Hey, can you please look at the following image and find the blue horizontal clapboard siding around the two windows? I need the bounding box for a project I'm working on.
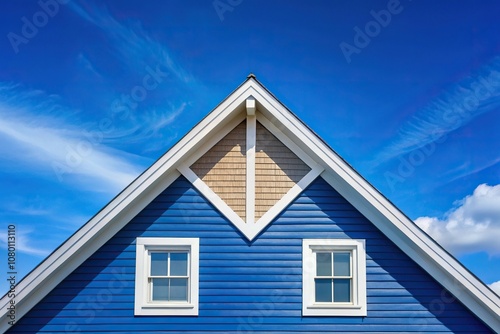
[10,177,490,333]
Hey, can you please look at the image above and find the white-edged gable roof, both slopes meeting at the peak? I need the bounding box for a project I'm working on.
[0,75,500,332]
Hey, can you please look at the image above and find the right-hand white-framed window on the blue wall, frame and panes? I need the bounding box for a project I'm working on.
[302,239,366,316]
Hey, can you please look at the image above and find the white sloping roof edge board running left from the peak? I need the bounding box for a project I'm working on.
[0,80,254,332]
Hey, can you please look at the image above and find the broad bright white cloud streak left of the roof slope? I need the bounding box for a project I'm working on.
[0,84,143,193]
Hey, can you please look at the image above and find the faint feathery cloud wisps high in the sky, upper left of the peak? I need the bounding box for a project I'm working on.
[68,1,201,154]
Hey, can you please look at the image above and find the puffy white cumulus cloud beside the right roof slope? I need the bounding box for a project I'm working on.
[415,184,500,256]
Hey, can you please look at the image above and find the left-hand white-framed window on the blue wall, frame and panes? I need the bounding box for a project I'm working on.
[135,238,199,315]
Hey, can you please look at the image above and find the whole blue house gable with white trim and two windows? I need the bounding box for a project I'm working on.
[0,75,500,333]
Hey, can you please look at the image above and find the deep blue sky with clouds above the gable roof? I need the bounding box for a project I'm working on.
[0,0,500,292]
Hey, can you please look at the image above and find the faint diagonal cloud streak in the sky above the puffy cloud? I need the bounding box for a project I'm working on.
[373,57,500,165]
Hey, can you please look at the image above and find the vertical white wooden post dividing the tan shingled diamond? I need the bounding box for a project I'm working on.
[245,114,257,224]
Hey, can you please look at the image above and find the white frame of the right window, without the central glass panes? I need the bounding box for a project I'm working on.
[302,239,367,316]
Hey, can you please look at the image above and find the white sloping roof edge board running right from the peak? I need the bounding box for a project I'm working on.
[245,79,500,332]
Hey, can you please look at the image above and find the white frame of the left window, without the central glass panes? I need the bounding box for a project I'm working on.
[134,238,200,315]
